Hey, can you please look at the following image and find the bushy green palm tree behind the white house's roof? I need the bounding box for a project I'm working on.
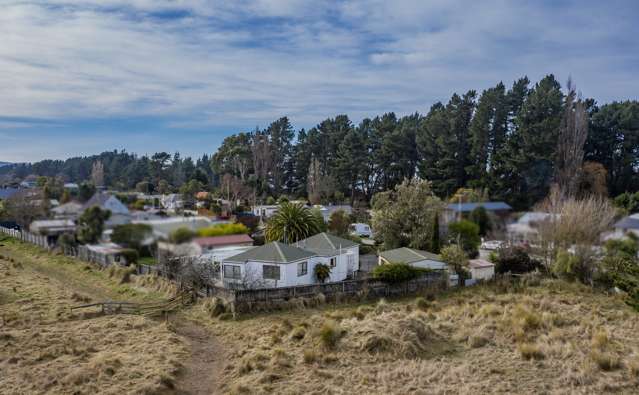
[265,202,320,243]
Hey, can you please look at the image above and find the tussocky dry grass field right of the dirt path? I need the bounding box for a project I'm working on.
[189,280,639,394]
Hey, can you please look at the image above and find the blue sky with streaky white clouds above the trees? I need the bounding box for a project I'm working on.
[0,0,639,162]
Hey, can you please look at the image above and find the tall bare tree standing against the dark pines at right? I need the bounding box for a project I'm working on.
[555,80,588,197]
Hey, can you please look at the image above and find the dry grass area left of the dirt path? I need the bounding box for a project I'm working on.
[0,240,187,394]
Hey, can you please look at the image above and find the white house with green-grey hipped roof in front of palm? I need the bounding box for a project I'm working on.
[221,233,359,288]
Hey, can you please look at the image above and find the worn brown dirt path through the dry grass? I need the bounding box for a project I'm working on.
[172,315,223,395]
